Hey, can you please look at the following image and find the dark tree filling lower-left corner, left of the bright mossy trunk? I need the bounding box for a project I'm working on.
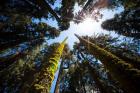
[0,42,42,93]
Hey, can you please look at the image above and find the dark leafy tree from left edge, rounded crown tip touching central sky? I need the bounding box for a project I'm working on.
[0,15,60,50]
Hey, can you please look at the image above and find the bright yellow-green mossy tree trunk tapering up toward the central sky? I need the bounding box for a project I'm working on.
[29,38,67,93]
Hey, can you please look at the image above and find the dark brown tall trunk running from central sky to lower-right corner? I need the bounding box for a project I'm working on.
[76,35,140,93]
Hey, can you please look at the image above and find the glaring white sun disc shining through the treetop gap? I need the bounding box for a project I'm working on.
[78,17,96,34]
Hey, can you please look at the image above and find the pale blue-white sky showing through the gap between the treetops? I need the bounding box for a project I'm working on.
[47,6,123,49]
